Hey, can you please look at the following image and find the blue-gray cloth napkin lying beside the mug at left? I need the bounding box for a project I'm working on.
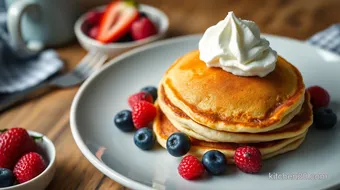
[0,3,64,94]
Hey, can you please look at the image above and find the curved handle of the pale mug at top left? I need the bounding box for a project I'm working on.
[7,0,44,53]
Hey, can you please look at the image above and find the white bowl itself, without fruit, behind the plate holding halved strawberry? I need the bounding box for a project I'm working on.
[74,4,169,57]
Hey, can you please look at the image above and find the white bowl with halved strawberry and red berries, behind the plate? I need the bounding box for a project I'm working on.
[74,0,169,57]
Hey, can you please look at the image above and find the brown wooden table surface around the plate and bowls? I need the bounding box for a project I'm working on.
[0,0,340,190]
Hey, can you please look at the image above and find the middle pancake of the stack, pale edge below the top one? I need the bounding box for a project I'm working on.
[158,86,313,143]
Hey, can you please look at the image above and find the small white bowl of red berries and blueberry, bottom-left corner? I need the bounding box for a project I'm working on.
[0,128,56,190]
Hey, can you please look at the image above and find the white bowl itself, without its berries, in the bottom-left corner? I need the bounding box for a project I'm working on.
[0,131,56,190]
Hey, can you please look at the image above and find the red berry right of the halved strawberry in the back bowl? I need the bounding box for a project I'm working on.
[130,17,157,40]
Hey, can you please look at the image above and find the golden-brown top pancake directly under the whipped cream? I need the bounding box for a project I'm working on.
[161,50,305,133]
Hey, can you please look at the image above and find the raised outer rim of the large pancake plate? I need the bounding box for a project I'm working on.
[70,34,340,190]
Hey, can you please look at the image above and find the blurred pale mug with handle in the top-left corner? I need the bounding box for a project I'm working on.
[6,0,83,52]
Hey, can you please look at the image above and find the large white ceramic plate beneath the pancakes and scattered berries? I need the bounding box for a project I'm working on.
[71,35,340,190]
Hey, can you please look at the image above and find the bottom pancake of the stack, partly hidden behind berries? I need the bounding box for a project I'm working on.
[153,106,307,163]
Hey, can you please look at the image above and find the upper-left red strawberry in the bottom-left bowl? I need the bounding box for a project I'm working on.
[0,128,37,169]
